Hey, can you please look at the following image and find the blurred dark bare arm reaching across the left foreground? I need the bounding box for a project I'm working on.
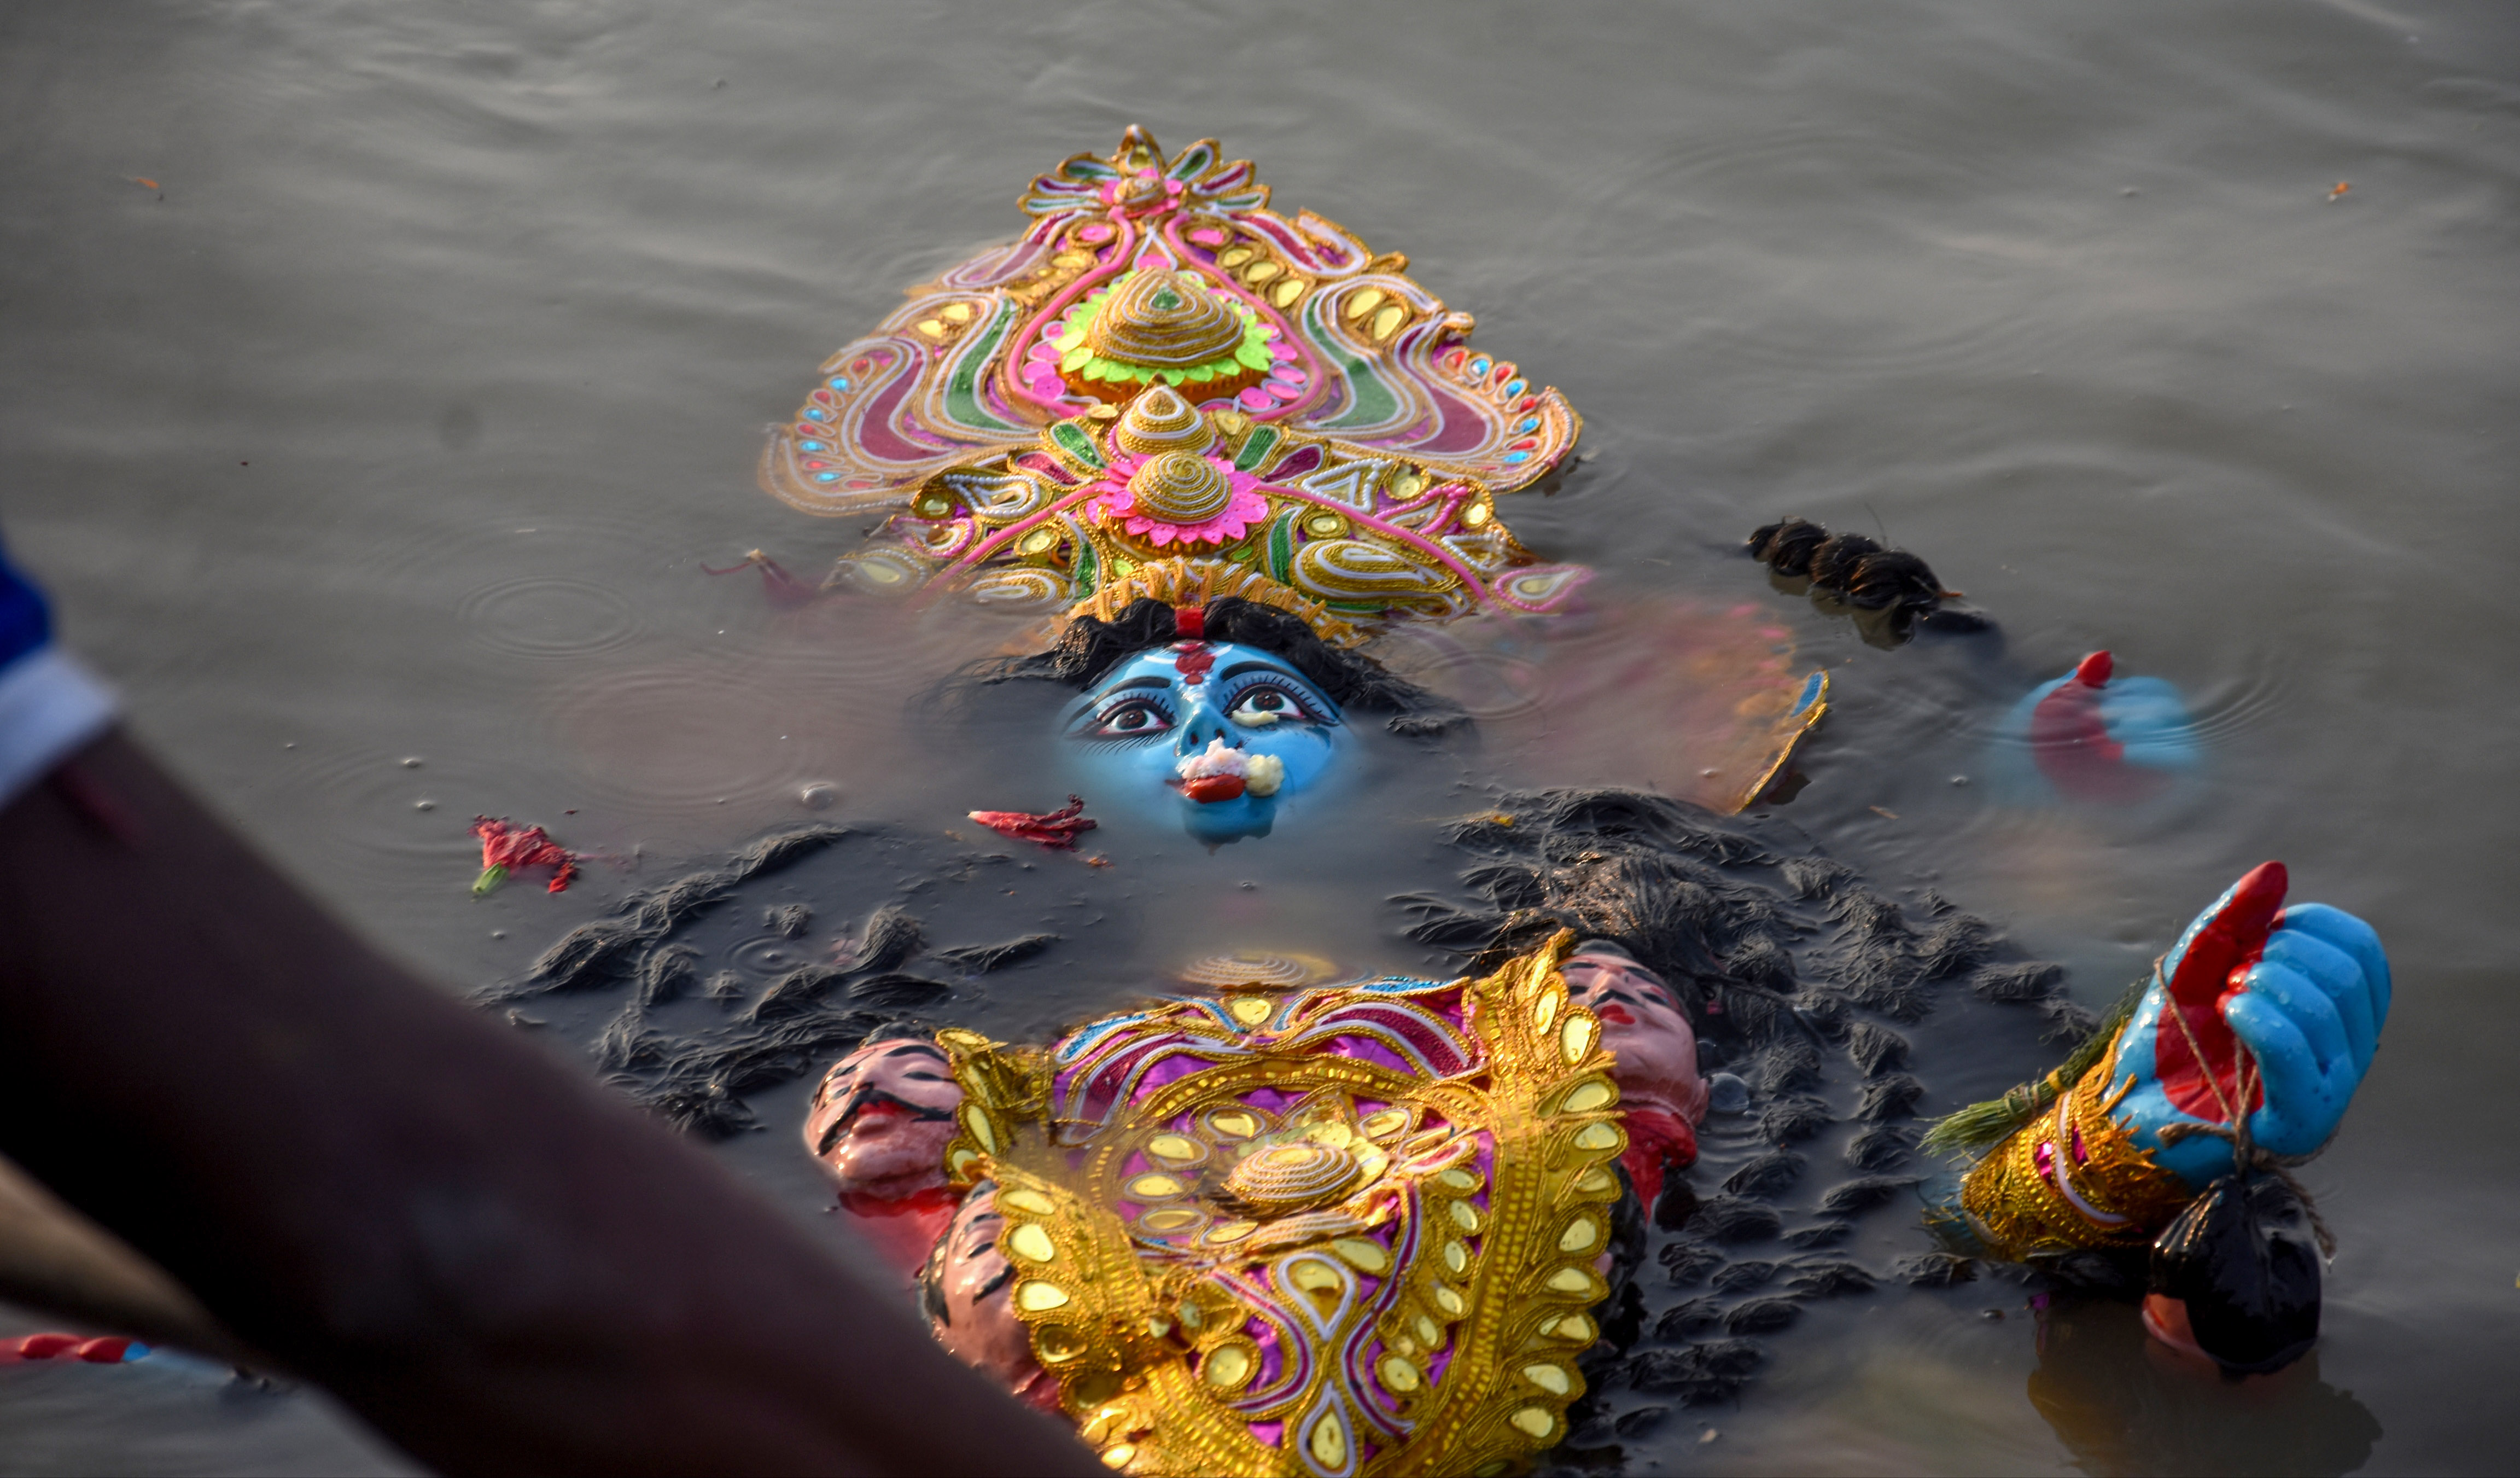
[0,734,1101,1473]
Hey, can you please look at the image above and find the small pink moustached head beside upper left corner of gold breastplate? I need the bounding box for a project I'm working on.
[804,1041,962,1201]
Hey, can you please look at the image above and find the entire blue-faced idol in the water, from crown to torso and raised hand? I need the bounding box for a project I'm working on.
[673,129,2389,1478]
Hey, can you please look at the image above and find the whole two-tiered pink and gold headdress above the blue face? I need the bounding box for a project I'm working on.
[761,126,1588,643]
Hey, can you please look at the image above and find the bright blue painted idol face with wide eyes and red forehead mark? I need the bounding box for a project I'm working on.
[1066,641,1346,845]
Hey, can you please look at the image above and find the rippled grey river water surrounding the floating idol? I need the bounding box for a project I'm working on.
[0,0,2520,1473]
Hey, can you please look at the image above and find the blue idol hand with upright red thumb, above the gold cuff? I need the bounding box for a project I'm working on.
[2112,863,2389,1188]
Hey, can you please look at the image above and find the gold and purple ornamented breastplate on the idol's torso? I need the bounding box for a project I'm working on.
[940,933,1625,1478]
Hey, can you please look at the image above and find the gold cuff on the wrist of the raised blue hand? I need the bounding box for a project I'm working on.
[1961,1027,2195,1261]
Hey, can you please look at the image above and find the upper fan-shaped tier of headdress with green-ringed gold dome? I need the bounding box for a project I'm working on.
[761,126,1583,515]
